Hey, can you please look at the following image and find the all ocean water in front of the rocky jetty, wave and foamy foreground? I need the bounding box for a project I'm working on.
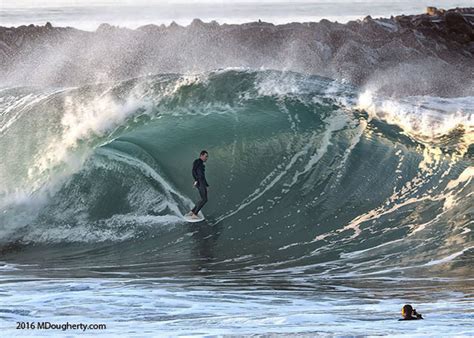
[0,69,474,337]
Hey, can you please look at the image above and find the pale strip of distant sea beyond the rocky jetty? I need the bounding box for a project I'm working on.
[0,0,472,31]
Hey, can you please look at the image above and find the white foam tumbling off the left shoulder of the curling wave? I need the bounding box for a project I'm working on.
[0,74,207,211]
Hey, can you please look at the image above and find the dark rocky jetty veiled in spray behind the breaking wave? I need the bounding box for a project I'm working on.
[0,7,474,96]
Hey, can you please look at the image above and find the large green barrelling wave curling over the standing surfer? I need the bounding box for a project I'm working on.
[0,70,473,274]
